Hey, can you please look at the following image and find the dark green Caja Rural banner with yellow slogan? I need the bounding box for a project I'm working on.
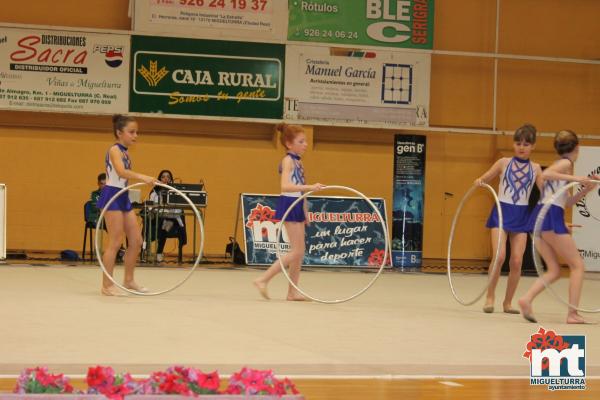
[130,36,285,119]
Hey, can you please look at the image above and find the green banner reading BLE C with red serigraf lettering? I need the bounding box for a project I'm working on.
[288,0,434,49]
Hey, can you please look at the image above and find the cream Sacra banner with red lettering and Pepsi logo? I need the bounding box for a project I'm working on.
[0,27,129,114]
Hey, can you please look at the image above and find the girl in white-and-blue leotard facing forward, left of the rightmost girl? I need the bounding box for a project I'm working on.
[475,124,542,314]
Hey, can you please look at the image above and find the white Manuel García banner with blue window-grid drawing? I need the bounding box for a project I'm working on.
[285,45,431,126]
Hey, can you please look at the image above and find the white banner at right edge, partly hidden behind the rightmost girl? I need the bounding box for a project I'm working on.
[573,146,600,271]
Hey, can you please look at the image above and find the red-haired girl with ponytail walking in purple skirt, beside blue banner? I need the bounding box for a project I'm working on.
[254,123,325,301]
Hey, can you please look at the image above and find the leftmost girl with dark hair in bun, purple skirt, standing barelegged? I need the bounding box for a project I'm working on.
[97,114,155,296]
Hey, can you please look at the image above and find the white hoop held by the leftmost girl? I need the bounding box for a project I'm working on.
[95,182,204,296]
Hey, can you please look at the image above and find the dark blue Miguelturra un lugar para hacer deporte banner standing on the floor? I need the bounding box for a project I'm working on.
[241,193,389,268]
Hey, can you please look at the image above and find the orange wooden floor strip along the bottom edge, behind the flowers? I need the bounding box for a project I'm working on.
[0,378,600,400]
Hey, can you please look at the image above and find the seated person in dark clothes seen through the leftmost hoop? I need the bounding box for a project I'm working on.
[150,169,187,262]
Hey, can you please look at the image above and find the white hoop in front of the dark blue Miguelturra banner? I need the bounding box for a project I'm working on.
[275,186,390,304]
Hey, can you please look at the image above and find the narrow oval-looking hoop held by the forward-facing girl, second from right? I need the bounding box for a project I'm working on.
[446,183,504,306]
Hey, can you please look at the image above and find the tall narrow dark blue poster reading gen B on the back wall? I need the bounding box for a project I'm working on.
[392,135,426,270]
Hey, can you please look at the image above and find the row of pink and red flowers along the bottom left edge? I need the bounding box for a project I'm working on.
[14,365,299,400]
